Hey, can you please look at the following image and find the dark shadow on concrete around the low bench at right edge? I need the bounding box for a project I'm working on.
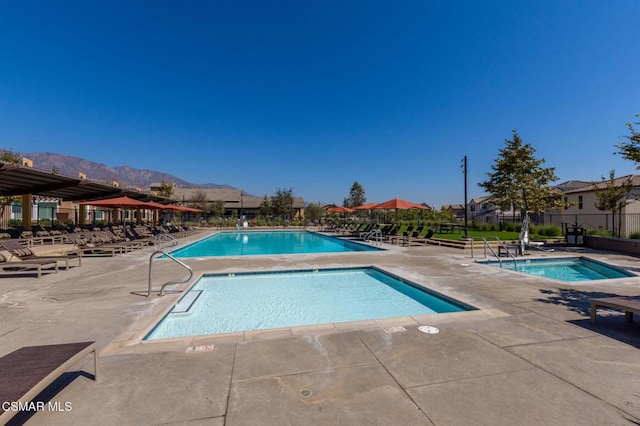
[536,288,640,349]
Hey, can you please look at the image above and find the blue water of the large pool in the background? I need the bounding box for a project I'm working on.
[171,231,380,257]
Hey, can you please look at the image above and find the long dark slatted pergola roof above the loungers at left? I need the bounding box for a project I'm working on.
[0,162,172,229]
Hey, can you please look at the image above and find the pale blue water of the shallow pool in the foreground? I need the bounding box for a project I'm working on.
[145,268,474,340]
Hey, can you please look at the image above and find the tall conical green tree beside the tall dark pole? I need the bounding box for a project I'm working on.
[478,130,562,219]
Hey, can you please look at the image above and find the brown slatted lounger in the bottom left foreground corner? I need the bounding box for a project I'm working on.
[0,342,98,424]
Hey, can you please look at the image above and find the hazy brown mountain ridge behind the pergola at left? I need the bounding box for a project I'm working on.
[24,152,238,190]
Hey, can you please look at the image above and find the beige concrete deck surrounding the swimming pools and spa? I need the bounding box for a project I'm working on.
[0,233,640,426]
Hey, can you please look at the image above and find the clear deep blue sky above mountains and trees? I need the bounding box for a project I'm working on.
[0,0,640,207]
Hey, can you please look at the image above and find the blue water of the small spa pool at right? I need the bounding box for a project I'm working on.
[487,257,636,281]
